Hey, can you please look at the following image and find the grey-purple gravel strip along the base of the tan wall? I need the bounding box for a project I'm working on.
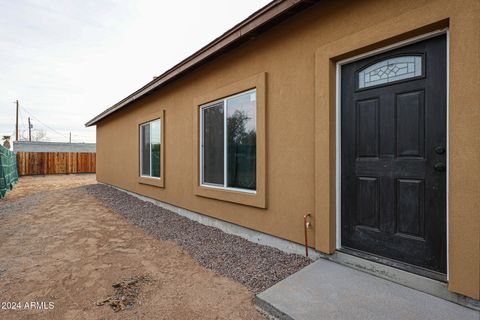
[82,184,312,293]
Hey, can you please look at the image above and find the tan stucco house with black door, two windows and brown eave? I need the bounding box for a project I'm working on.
[86,0,480,303]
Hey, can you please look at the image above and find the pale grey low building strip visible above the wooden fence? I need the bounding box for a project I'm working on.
[13,141,96,153]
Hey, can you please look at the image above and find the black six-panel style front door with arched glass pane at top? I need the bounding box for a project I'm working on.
[341,36,447,274]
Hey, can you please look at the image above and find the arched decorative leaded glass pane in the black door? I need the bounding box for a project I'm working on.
[358,55,423,89]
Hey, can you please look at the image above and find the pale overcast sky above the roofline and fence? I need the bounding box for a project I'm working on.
[0,0,270,142]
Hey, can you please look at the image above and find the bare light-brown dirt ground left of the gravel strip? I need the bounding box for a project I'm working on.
[0,175,263,319]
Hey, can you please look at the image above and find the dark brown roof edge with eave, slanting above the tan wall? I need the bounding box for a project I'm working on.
[85,0,318,127]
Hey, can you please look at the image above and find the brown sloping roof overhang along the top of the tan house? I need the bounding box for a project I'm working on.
[85,0,320,127]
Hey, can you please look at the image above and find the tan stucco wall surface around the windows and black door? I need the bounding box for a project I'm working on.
[97,0,480,299]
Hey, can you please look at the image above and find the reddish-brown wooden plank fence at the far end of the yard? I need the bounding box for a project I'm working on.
[17,152,96,176]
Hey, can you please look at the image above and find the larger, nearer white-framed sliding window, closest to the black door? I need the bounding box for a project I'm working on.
[200,89,257,193]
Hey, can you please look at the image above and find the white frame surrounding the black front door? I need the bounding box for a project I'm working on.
[335,28,450,281]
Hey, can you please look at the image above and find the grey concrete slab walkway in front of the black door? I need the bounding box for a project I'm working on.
[256,259,480,320]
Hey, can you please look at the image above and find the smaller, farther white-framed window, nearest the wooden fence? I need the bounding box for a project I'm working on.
[140,119,161,179]
